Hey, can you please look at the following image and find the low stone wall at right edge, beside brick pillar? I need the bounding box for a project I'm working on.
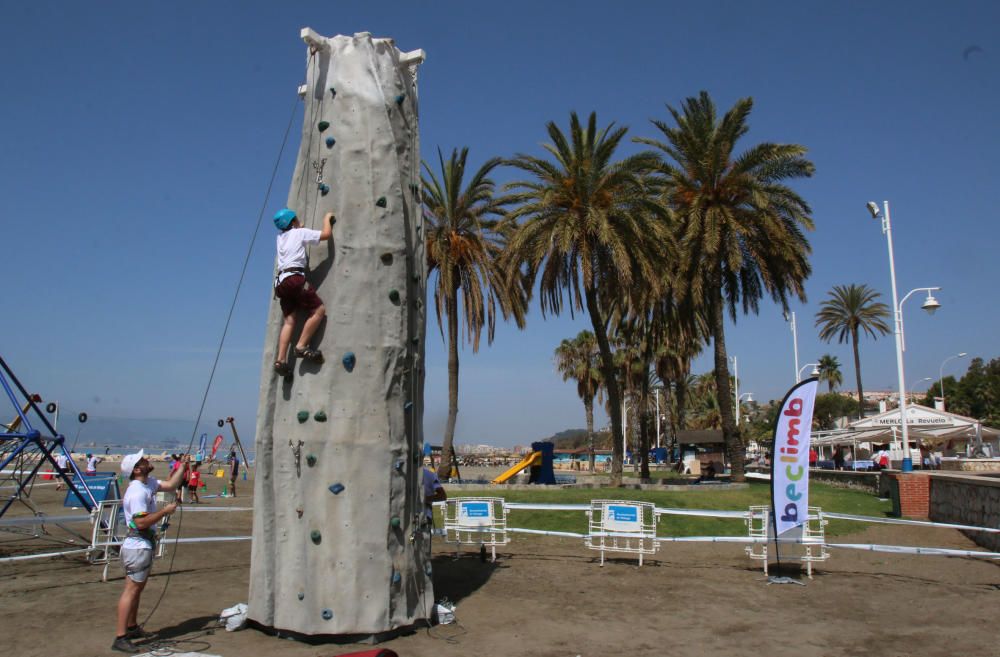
[930,472,1000,552]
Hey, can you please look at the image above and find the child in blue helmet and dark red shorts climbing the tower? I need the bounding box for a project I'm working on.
[274,208,336,377]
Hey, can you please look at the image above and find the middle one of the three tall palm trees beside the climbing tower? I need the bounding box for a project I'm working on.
[506,112,672,483]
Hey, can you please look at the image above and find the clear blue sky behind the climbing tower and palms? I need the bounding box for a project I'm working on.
[0,0,1000,446]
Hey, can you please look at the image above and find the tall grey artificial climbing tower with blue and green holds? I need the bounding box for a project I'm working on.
[249,31,434,635]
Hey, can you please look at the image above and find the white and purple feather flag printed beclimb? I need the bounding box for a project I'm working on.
[771,378,819,537]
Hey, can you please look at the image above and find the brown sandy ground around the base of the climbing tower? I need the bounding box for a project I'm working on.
[0,478,1000,657]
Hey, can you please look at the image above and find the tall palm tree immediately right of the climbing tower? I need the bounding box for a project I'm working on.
[422,148,527,477]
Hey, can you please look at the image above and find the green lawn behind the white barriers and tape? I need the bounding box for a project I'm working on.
[446,482,892,536]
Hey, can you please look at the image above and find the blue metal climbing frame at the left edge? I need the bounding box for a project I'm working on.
[0,356,97,518]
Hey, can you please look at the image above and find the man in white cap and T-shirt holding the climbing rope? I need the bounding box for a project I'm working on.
[111,450,187,653]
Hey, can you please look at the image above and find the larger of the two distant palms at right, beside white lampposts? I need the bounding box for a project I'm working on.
[816,283,891,418]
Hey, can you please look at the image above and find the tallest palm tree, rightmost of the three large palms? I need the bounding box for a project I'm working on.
[639,91,814,481]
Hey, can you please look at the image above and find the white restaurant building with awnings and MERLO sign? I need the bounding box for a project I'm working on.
[812,404,1000,462]
